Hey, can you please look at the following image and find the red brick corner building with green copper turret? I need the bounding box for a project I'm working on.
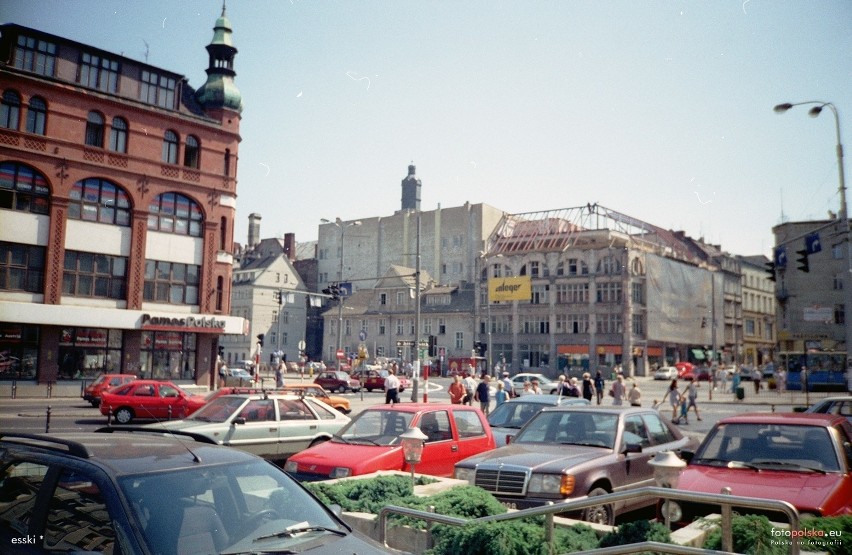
[0,10,245,385]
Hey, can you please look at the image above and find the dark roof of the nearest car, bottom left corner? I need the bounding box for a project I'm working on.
[0,430,255,475]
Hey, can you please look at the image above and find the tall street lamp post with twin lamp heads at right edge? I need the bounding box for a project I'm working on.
[774,100,852,394]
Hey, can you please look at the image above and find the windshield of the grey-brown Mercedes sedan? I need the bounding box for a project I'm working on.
[512,411,618,449]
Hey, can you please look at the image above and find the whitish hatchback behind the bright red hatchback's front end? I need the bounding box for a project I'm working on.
[145,394,349,460]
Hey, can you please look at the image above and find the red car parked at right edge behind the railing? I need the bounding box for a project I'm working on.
[663,413,852,523]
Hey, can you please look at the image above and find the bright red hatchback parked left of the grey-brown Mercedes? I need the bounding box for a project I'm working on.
[284,403,494,480]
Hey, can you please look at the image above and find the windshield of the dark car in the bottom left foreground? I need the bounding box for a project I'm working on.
[119,461,349,555]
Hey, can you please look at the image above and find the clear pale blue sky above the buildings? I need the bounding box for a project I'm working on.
[0,0,852,255]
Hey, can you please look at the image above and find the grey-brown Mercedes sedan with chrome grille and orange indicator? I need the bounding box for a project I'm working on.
[455,406,698,524]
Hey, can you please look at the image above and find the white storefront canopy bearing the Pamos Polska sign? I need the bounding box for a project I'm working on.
[0,301,248,335]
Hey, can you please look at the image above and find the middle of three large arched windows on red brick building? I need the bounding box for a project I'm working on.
[68,177,130,226]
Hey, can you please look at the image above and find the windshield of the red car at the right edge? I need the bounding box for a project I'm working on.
[692,423,840,472]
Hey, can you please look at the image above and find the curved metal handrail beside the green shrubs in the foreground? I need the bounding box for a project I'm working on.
[379,486,799,555]
